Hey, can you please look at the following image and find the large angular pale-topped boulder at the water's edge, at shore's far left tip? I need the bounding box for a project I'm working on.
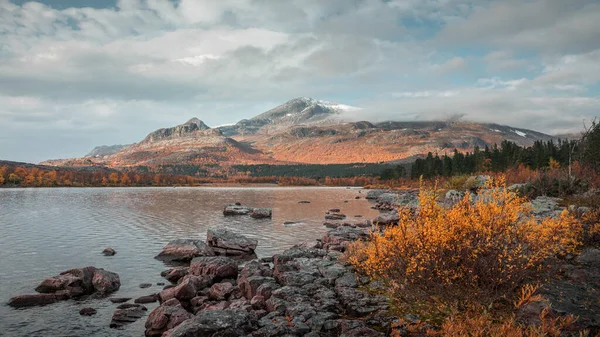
[206,227,258,256]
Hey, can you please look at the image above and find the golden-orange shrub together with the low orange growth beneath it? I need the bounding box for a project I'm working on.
[345,178,597,336]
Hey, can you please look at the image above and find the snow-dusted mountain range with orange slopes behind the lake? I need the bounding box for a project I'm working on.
[45,97,553,171]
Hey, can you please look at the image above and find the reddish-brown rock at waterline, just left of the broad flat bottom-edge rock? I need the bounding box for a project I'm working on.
[145,299,193,337]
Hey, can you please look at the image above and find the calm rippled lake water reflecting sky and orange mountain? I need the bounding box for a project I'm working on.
[0,187,377,337]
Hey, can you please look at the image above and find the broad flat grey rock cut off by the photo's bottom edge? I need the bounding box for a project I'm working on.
[163,310,250,337]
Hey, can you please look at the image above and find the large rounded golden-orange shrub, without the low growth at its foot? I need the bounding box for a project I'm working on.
[345,178,581,308]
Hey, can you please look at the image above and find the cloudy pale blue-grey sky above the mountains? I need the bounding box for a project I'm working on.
[0,0,600,162]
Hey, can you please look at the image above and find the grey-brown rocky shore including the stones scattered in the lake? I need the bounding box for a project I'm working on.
[9,191,600,337]
